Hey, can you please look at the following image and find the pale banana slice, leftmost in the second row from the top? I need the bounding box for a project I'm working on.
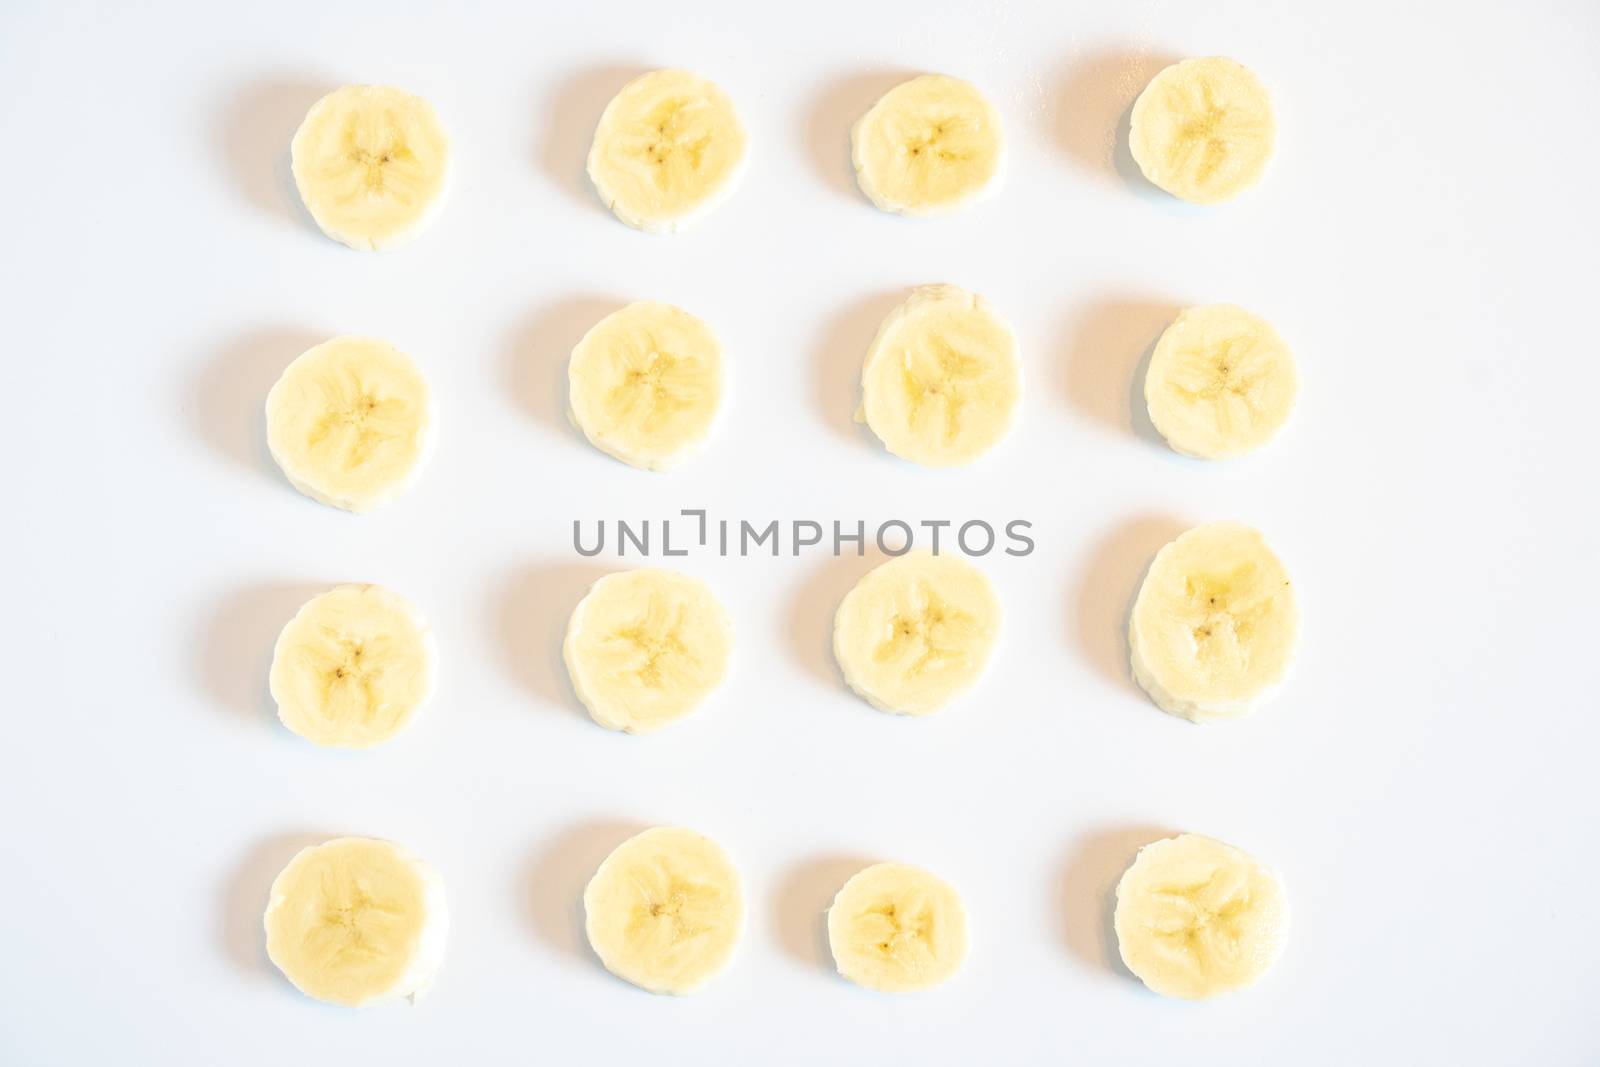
[267,338,434,512]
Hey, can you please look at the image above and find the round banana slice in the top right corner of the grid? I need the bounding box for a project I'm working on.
[1128,58,1277,203]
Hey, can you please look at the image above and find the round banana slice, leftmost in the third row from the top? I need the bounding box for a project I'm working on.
[269,585,437,749]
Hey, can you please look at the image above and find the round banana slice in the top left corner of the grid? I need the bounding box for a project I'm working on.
[290,85,450,251]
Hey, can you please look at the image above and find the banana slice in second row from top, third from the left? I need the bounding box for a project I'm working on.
[861,285,1022,467]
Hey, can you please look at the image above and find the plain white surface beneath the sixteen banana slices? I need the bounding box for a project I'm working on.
[0,0,1600,1064]
